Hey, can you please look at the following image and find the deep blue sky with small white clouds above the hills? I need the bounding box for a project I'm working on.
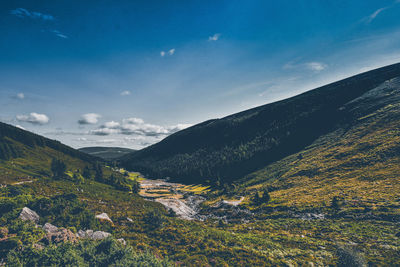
[0,0,400,149]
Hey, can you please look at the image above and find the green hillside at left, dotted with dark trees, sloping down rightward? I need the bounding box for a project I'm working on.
[0,122,101,183]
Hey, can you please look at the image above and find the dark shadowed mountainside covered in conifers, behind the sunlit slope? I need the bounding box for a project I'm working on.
[121,64,400,183]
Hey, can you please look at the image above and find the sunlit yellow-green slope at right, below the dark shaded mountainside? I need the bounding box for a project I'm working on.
[236,77,400,208]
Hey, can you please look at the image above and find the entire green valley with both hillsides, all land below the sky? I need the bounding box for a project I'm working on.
[0,64,400,266]
